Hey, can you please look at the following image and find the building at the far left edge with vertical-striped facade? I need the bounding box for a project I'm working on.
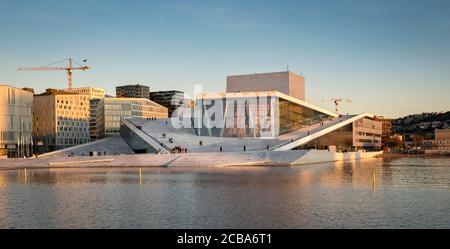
[0,85,33,157]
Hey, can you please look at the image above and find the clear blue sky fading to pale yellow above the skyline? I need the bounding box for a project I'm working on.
[0,0,450,117]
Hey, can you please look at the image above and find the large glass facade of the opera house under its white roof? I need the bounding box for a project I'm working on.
[194,95,330,138]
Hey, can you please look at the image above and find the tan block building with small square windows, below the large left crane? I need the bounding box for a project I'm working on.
[33,89,90,153]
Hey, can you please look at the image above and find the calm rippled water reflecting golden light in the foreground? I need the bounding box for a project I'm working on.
[0,158,450,228]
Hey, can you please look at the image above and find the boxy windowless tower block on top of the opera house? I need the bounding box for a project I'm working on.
[227,71,305,100]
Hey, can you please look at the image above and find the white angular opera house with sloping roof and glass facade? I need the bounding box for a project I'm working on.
[42,72,382,162]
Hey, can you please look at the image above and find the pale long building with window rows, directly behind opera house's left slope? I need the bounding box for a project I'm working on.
[97,98,168,137]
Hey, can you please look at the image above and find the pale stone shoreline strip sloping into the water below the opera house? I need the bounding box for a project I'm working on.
[0,150,382,170]
